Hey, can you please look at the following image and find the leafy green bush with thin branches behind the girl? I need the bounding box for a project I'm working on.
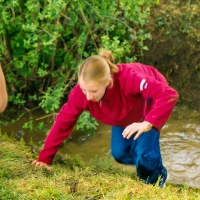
[0,0,158,133]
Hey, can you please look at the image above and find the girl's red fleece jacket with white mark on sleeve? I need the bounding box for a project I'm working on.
[38,63,178,164]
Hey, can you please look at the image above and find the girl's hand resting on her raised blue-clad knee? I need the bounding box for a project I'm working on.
[122,121,153,140]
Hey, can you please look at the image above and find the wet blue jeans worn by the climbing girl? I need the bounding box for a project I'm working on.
[111,126,164,184]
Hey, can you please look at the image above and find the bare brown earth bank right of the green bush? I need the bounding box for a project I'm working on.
[144,0,200,110]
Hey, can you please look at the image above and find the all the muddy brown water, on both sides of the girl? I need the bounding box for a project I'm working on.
[1,106,200,188]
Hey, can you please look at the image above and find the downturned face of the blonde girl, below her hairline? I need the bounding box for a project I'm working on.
[79,79,111,102]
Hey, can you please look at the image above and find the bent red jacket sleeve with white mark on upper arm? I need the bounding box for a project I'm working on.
[132,74,178,130]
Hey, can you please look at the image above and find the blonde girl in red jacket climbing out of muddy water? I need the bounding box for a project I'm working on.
[32,50,178,187]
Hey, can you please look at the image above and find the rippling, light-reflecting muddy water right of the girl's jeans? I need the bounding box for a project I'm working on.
[161,108,200,188]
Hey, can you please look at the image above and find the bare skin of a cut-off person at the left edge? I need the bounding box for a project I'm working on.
[0,64,8,113]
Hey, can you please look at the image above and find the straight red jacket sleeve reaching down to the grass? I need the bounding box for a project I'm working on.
[38,86,87,164]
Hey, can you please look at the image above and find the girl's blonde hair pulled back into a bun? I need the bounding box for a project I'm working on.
[78,50,118,82]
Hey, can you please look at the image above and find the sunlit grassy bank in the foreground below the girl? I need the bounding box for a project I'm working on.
[0,134,200,200]
